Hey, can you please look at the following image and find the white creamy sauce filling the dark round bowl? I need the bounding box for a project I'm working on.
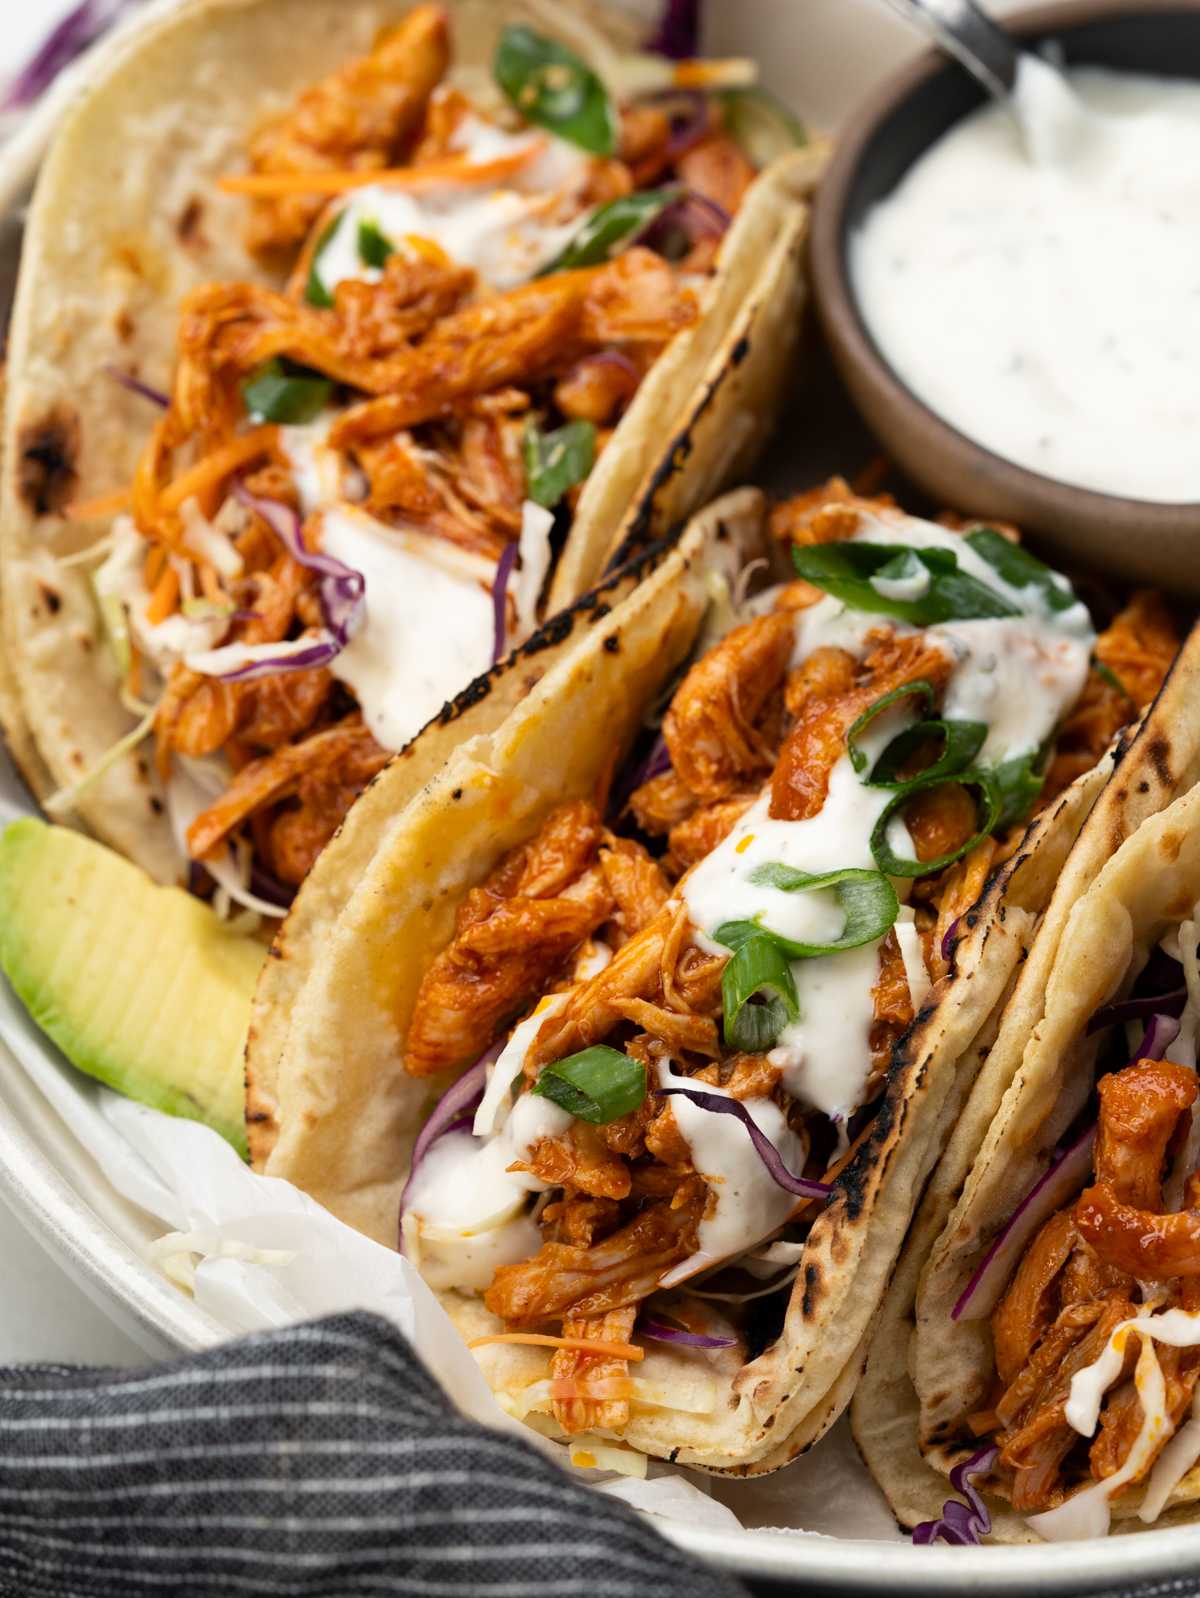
[850,56,1200,503]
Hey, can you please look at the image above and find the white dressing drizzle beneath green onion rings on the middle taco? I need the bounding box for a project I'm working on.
[682,513,1095,1123]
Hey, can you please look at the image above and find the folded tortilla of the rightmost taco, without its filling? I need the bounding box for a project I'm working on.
[852,631,1200,1542]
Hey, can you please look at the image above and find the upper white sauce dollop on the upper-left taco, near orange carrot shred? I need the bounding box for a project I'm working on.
[313,118,588,294]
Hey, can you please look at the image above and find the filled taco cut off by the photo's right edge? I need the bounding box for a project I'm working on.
[853,631,1200,1542]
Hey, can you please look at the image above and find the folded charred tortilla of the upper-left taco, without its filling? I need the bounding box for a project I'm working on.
[0,0,828,882]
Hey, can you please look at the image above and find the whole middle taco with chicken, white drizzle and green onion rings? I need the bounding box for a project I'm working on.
[248,483,1170,1475]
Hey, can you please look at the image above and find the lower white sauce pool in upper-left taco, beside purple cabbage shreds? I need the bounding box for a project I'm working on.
[321,505,495,749]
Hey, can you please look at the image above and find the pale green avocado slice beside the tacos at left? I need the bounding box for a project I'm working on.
[0,817,267,1155]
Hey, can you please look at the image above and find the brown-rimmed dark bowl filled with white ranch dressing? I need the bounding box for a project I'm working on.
[812,0,1200,594]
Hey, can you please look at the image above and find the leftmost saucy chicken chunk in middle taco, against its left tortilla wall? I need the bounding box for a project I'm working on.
[404,801,620,1077]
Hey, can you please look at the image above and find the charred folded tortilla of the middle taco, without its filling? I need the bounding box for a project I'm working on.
[248,491,1137,1475]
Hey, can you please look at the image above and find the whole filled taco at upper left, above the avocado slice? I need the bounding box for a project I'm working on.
[0,0,823,916]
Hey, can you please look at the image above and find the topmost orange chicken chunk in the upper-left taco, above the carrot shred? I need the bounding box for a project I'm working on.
[248,5,451,256]
